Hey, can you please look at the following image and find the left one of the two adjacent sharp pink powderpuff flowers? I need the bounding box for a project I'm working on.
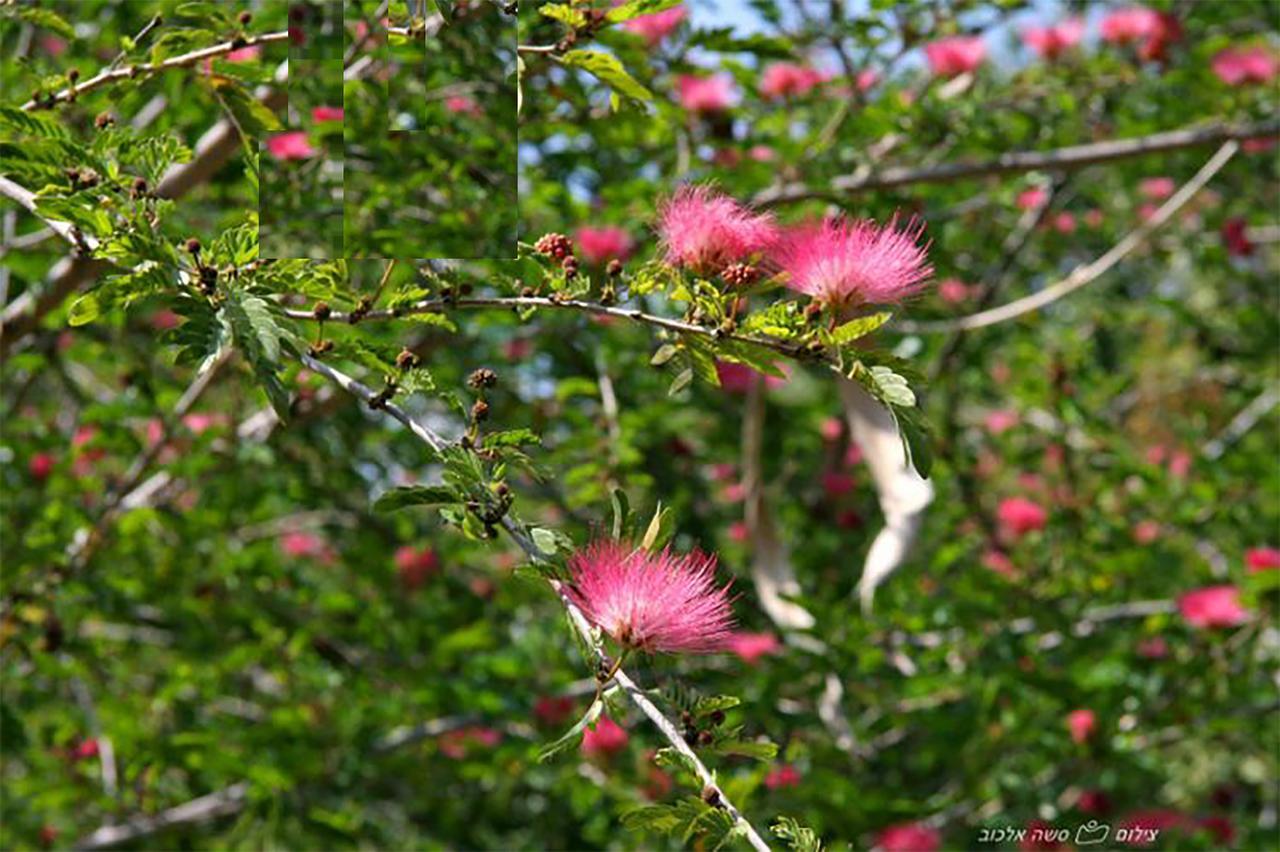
[658,185,778,275]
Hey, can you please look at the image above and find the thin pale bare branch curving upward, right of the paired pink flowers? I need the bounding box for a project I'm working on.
[897,139,1240,334]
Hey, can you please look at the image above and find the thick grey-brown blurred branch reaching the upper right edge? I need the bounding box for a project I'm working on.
[753,119,1280,206]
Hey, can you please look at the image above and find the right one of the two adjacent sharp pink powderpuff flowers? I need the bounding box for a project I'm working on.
[777,216,933,307]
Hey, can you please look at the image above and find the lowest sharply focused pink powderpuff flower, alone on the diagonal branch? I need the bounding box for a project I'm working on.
[567,540,733,654]
